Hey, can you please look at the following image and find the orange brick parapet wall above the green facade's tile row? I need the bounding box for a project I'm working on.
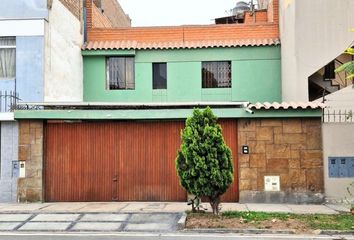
[88,23,279,42]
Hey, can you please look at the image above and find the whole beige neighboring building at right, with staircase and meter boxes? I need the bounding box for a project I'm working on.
[279,0,354,201]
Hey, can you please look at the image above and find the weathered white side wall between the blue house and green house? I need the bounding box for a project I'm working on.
[44,1,83,102]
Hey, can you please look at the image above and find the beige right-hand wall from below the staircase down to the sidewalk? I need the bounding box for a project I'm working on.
[322,86,354,202]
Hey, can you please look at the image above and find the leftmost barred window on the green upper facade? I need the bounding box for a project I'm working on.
[106,57,135,90]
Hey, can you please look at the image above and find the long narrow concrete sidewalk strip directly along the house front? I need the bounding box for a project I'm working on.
[0,202,349,214]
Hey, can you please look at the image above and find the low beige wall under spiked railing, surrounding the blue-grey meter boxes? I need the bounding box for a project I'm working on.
[323,123,354,202]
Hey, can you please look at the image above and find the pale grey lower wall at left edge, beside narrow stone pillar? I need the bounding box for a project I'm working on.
[0,122,18,202]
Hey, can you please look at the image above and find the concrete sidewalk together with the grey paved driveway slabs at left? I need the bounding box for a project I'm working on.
[0,202,348,232]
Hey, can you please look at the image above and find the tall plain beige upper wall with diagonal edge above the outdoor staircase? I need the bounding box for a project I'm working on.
[280,0,354,101]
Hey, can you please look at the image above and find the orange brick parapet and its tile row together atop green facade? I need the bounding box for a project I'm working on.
[82,24,280,50]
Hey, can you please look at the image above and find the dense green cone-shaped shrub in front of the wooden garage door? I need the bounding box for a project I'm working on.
[176,107,234,214]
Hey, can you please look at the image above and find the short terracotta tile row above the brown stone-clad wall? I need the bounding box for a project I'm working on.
[247,102,325,110]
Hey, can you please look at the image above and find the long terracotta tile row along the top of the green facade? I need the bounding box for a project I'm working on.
[82,39,280,50]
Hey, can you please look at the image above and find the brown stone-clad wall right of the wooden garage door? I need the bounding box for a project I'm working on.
[238,118,324,203]
